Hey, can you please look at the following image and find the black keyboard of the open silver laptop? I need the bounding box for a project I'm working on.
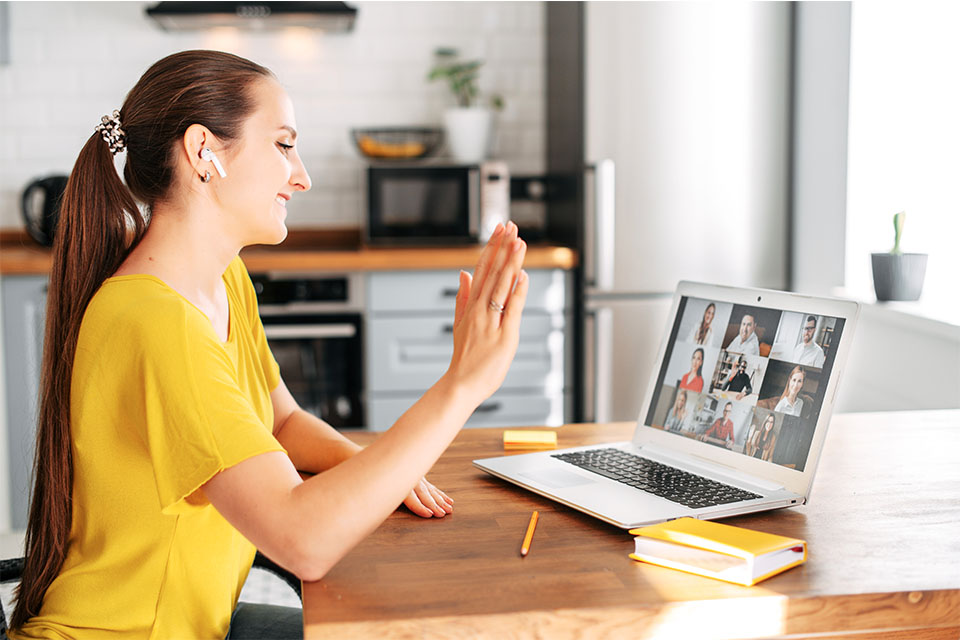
[553,449,762,509]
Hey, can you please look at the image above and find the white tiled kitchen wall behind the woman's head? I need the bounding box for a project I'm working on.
[0,2,545,227]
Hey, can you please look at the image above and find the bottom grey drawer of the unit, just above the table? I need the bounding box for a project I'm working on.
[367,390,569,431]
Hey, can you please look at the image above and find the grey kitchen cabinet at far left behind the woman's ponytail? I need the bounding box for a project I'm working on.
[0,275,48,530]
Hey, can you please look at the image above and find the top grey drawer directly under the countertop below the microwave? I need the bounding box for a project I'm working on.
[367,269,569,317]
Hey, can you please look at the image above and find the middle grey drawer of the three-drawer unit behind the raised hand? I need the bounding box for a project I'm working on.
[366,313,566,394]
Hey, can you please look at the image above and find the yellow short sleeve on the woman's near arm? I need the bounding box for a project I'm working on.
[139,305,284,515]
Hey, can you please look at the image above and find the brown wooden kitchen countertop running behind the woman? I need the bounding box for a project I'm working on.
[0,229,579,275]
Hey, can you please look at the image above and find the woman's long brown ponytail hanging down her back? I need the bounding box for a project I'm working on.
[10,133,146,628]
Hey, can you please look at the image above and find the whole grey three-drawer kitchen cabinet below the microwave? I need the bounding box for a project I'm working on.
[364,269,572,431]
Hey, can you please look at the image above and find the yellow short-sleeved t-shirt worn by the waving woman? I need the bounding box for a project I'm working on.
[14,257,283,639]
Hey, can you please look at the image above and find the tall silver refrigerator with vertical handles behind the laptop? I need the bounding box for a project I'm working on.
[547,2,793,422]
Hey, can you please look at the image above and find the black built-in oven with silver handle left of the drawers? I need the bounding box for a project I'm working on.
[251,273,365,429]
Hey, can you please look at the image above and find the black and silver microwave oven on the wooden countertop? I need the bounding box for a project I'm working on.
[365,162,510,245]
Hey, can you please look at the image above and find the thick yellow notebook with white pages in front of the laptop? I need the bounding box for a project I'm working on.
[630,518,807,587]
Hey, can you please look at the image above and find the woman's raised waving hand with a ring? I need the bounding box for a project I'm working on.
[447,222,530,405]
